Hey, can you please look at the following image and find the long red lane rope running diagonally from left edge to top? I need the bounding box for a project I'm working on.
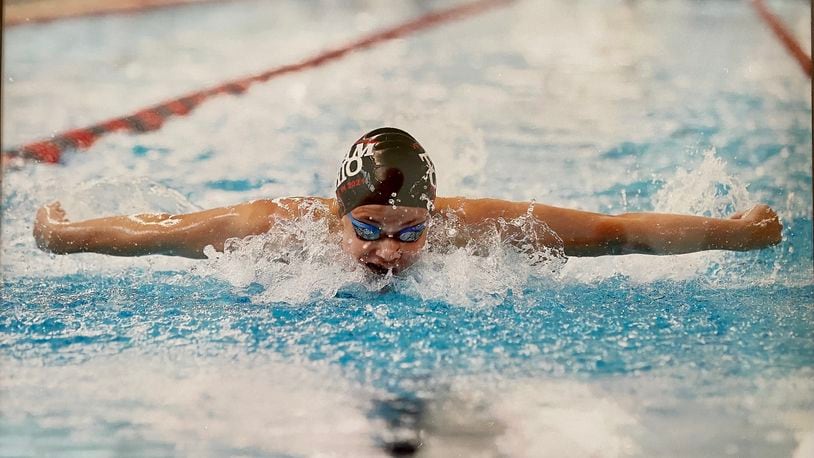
[2,0,513,165]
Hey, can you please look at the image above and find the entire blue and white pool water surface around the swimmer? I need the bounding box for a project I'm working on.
[0,0,814,457]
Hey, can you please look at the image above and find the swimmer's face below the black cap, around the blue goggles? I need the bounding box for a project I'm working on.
[342,205,430,273]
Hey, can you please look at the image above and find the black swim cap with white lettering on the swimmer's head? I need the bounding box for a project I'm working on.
[336,127,435,216]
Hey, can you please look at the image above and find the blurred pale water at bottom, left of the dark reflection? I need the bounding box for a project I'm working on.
[0,352,381,456]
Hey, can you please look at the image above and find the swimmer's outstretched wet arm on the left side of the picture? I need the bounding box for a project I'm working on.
[34,199,330,259]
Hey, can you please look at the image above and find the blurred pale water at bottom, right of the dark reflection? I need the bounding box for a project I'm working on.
[419,369,814,458]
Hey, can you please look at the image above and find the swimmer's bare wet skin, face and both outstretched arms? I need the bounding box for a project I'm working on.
[32,197,783,272]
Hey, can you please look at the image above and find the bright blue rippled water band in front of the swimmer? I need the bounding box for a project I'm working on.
[0,272,814,380]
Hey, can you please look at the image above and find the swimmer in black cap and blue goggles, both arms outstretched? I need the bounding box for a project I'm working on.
[34,127,782,273]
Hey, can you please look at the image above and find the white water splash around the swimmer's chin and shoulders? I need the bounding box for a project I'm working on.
[197,204,565,307]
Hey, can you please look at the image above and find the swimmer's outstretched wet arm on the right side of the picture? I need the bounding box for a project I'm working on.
[439,198,782,256]
